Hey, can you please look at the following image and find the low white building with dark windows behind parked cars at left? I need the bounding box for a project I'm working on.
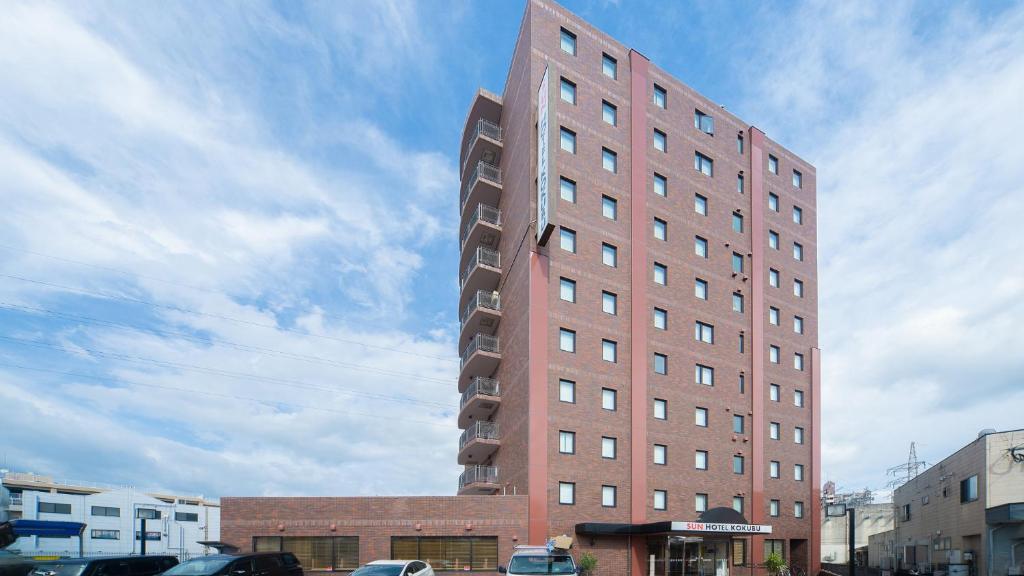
[0,472,220,557]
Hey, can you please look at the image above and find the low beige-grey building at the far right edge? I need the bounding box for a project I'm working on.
[888,429,1024,576]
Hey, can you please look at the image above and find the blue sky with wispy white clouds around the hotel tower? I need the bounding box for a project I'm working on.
[0,0,1024,495]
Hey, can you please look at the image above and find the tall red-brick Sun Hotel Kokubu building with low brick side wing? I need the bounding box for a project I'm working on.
[223,0,820,576]
